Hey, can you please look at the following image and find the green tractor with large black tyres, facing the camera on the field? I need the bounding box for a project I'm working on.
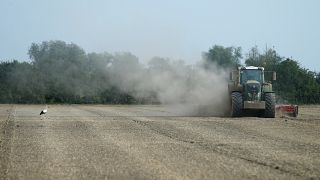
[228,66,276,118]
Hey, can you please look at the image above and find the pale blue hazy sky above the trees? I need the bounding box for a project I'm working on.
[0,0,320,71]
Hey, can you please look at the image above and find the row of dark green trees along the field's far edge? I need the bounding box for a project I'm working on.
[0,41,320,104]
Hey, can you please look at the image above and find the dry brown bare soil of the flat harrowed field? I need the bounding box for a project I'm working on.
[0,105,320,179]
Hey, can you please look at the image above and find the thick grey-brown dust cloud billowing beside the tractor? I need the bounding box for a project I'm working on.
[109,56,229,116]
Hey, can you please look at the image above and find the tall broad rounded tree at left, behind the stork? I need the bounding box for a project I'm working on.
[29,41,89,102]
